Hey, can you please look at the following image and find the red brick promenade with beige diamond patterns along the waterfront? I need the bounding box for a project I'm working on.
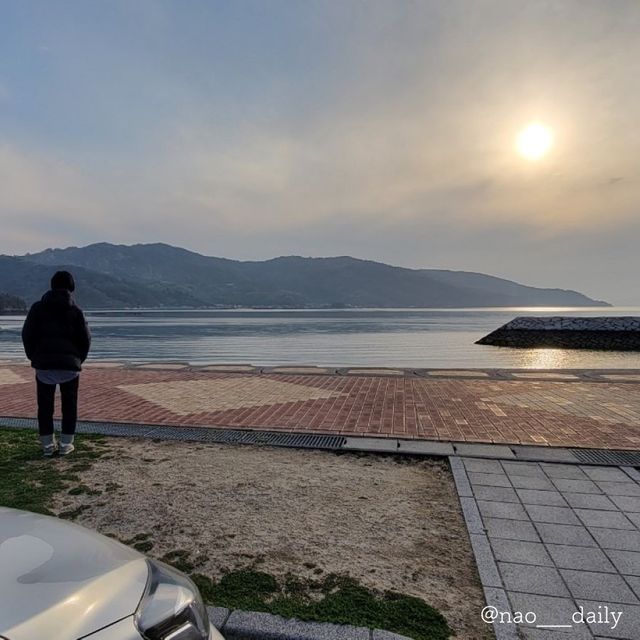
[0,363,640,450]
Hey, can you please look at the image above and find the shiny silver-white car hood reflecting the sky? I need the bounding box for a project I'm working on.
[0,507,148,640]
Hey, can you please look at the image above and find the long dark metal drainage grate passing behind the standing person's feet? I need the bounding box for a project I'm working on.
[0,417,347,450]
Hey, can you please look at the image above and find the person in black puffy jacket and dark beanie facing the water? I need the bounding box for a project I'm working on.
[22,271,91,457]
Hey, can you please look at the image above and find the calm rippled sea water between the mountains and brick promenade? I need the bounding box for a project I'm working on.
[0,308,640,369]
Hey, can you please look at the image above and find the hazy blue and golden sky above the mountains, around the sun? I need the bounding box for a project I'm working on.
[0,0,640,305]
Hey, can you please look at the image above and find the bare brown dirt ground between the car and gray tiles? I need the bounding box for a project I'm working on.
[55,438,493,640]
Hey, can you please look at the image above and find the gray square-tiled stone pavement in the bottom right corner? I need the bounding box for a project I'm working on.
[450,457,640,640]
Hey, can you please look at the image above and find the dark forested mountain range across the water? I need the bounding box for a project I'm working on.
[0,242,609,309]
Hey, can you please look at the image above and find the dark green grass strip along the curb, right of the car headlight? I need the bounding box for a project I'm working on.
[191,569,453,640]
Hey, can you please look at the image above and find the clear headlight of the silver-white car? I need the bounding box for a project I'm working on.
[135,560,210,640]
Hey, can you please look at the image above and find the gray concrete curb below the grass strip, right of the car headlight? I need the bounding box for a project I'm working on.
[207,607,411,640]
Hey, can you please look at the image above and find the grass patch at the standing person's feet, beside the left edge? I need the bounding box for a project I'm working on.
[0,427,105,518]
